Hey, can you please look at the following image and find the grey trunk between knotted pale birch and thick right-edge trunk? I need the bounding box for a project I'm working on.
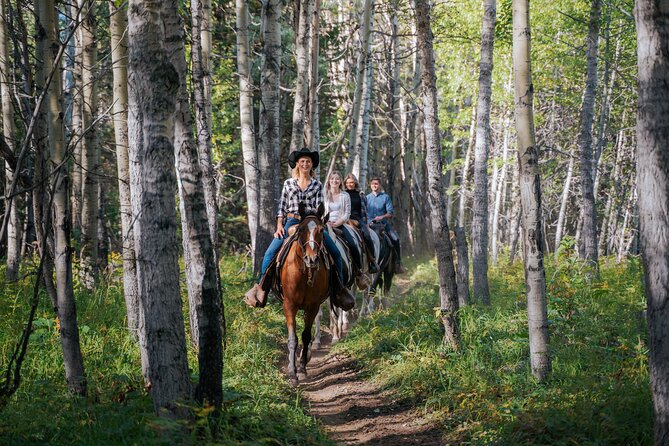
[578,0,601,269]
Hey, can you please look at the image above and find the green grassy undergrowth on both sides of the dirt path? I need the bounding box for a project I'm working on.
[0,255,652,445]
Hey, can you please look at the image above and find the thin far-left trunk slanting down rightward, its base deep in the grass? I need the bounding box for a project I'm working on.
[35,0,86,395]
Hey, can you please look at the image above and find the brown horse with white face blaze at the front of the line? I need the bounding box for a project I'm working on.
[275,204,336,385]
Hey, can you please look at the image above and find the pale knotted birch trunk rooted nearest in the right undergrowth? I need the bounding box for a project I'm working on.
[513,0,551,382]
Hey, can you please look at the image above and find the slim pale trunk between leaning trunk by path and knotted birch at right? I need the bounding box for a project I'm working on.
[472,0,497,305]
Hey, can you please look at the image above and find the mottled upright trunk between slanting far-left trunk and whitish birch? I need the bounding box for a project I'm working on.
[79,0,100,290]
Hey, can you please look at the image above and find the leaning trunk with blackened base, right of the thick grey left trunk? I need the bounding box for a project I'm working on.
[162,2,223,408]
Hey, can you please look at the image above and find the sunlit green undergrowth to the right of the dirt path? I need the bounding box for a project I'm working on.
[337,257,653,445]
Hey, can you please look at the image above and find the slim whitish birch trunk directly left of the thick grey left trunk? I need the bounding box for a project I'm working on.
[109,1,139,337]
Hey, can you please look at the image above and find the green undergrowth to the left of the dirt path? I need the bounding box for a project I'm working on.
[0,254,331,445]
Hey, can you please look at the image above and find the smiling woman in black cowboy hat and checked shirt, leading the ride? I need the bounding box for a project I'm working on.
[244,147,355,307]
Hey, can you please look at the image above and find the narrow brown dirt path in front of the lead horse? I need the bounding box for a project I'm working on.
[300,339,442,446]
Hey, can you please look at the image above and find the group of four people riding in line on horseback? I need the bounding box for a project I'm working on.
[244,148,405,309]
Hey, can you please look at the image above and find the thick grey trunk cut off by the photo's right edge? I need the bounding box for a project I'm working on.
[635,0,669,446]
